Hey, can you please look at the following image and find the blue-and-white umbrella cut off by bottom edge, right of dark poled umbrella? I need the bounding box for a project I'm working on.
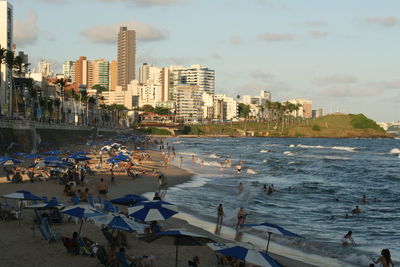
[207,243,281,267]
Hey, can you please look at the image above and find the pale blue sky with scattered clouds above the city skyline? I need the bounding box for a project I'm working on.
[9,0,400,121]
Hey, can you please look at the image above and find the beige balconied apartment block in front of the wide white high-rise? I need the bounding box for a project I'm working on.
[174,84,203,122]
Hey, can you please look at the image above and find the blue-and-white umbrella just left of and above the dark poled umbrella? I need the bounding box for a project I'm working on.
[93,213,144,234]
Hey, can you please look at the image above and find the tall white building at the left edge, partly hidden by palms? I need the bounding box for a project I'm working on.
[0,1,13,114]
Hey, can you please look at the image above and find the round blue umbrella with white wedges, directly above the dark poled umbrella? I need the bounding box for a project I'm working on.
[128,200,178,222]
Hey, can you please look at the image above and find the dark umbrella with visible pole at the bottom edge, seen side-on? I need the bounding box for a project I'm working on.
[143,229,214,267]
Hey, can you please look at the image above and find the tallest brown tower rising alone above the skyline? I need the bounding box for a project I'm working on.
[118,27,136,91]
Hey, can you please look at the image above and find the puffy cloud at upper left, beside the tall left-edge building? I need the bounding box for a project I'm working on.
[14,10,39,47]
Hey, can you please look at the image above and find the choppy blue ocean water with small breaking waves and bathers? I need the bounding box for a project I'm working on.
[165,138,400,266]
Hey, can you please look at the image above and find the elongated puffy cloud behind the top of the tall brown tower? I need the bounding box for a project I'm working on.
[80,20,169,44]
